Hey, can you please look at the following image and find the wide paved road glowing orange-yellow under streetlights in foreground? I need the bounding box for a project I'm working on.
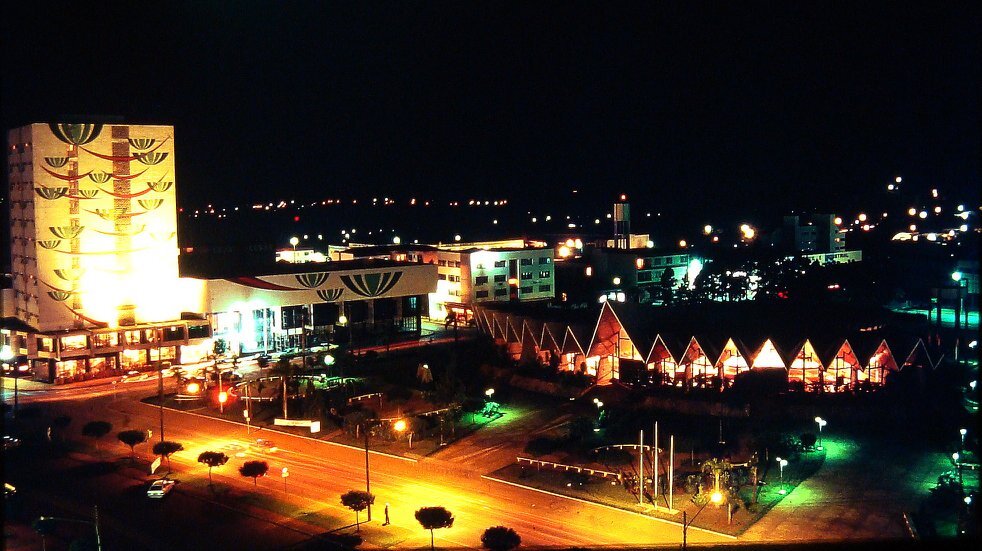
[26,398,728,548]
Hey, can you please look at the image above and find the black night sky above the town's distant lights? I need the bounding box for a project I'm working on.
[2,1,982,216]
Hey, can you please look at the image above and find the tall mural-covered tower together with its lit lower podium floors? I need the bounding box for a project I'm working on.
[4,123,210,380]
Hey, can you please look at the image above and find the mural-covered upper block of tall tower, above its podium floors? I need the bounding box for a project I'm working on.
[8,124,180,332]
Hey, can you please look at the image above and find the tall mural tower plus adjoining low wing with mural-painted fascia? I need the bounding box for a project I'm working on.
[2,124,437,383]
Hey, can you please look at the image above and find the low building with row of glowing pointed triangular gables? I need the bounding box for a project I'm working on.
[475,301,940,393]
